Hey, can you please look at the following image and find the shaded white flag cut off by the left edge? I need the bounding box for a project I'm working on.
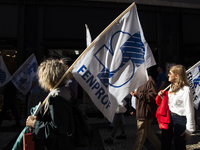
[0,56,11,87]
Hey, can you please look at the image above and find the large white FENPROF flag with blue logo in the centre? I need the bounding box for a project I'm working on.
[72,3,156,122]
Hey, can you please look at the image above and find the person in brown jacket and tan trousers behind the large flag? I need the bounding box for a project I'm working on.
[130,68,161,150]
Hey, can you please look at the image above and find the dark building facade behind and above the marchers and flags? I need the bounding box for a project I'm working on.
[0,0,200,115]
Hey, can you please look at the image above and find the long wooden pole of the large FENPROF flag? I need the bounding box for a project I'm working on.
[34,3,135,115]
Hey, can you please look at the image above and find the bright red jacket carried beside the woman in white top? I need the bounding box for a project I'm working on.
[155,91,170,129]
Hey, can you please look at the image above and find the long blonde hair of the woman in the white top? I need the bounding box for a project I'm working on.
[169,65,189,93]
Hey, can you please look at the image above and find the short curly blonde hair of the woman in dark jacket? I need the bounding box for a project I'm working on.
[37,59,69,91]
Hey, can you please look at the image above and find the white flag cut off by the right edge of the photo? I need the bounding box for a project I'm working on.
[187,62,200,109]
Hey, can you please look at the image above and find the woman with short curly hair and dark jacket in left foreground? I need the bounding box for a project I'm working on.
[26,59,74,150]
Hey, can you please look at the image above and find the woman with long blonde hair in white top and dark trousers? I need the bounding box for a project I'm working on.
[158,65,195,150]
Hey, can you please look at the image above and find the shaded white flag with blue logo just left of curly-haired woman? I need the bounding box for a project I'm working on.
[12,54,38,95]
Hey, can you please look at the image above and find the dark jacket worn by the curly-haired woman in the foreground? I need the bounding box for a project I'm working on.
[32,87,74,150]
